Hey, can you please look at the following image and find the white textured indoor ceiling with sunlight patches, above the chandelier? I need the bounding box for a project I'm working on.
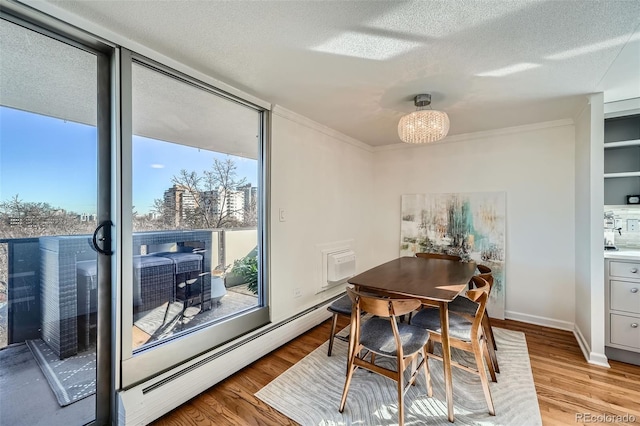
[26,0,640,146]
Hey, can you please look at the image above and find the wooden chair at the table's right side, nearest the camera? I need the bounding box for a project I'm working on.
[411,275,495,416]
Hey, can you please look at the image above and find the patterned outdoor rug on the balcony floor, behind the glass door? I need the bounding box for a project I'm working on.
[27,339,96,407]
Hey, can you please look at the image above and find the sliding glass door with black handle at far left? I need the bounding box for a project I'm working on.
[0,15,111,425]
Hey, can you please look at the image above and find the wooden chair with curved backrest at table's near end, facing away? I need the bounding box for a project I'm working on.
[340,288,433,425]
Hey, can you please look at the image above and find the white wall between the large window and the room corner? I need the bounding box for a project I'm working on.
[270,107,374,322]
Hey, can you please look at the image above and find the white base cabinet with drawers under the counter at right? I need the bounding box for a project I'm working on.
[605,259,640,365]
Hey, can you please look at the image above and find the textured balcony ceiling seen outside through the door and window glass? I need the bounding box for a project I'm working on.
[0,20,260,158]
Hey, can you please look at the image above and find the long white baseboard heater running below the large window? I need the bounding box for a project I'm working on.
[117,296,339,426]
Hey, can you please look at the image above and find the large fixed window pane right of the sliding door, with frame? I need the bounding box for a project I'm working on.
[123,57,268,384]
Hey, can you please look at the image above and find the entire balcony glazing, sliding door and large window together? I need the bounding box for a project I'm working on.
[0,3,269,425]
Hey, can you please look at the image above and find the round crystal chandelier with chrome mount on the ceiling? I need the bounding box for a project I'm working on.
[398,94,449,143]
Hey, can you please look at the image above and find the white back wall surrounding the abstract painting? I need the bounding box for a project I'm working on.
[373,121,575,330]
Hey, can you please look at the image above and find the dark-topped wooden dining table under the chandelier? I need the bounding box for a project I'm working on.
[348,257,476,422]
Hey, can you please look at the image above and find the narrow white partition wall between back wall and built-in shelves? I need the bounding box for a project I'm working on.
[575,93,608,365]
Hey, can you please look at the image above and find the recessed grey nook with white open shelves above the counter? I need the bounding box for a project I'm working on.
[604,114,640,205]
